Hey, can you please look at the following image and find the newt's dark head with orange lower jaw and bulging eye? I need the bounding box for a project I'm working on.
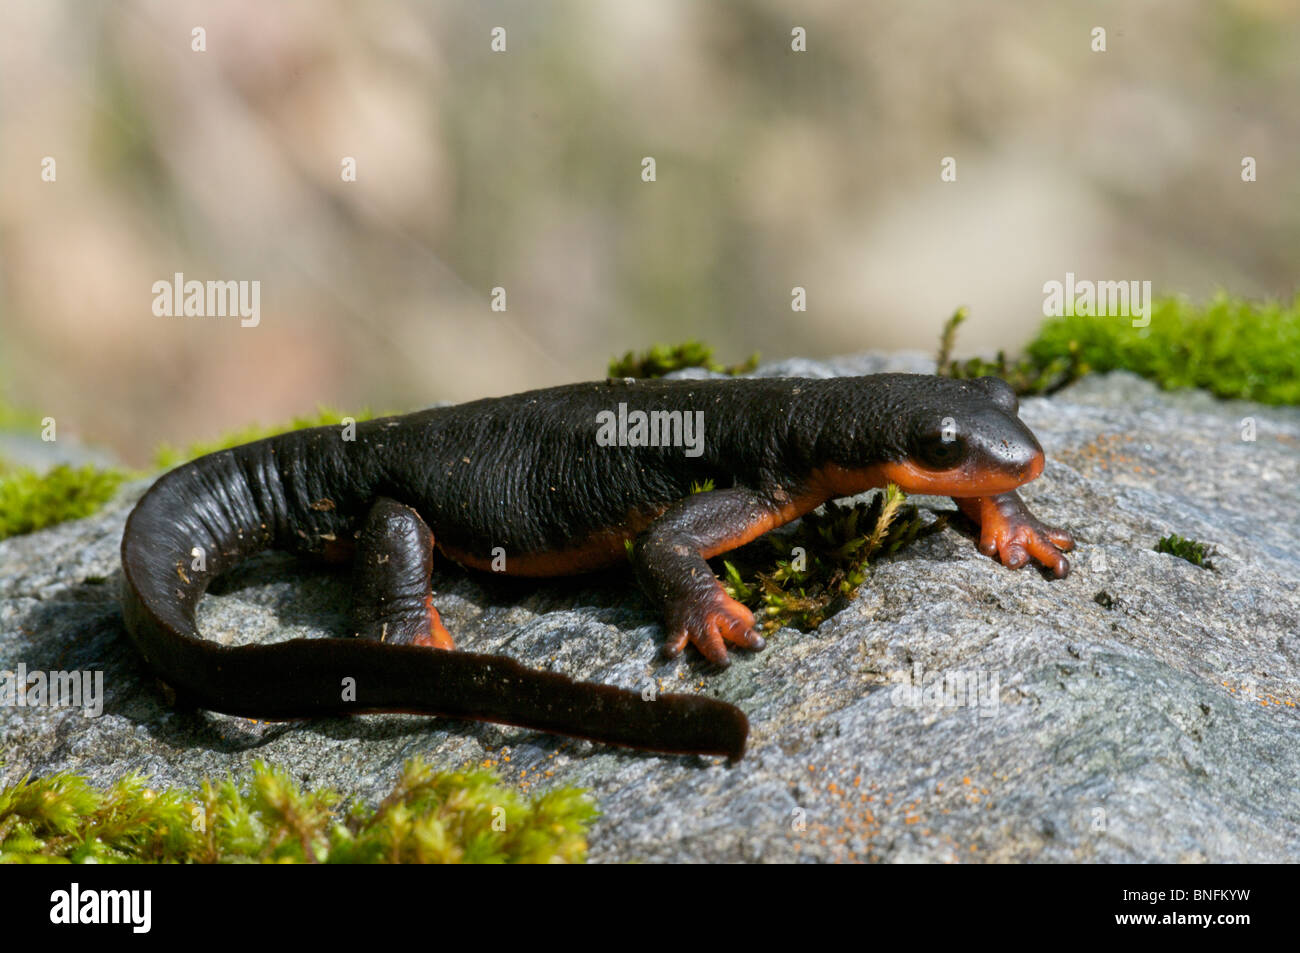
[835,374,1044,497]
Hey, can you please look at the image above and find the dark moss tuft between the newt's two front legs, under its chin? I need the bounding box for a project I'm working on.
[723,484,946,631]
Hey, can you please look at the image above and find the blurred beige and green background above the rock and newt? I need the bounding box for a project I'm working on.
[0,0,1300,464]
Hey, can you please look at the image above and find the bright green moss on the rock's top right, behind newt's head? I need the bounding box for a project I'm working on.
[1028,293,1300,404]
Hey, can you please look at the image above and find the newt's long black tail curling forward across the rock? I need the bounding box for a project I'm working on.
[122,432,749,759]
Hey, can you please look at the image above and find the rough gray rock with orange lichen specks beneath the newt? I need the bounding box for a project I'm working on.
[0,355,1300,862]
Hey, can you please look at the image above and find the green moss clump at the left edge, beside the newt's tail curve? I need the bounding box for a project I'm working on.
[0,464,127,540]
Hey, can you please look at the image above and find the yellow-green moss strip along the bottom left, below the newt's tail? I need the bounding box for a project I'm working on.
[0,759,597,863]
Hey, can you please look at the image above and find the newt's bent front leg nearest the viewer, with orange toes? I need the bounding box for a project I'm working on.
[633,486,792,666]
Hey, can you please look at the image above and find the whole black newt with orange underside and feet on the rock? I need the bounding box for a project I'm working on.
[122,374,1073,759]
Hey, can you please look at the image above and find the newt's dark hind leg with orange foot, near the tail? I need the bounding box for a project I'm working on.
[352,497,455,649]
